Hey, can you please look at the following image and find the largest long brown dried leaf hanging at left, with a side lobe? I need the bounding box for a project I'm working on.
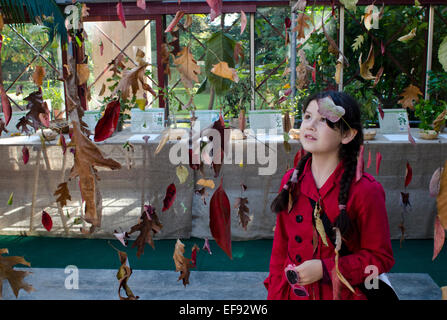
[70,121,121,232]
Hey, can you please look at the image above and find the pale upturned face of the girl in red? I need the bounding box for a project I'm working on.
[300,100,344,154]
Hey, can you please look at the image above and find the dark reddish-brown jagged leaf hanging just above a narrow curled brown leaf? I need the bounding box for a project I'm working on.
[127,206,163,258]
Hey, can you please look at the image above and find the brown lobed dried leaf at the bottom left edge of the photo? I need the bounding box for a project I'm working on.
[0,249,34,298]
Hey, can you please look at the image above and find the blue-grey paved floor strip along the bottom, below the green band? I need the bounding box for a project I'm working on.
[3,268,441,300]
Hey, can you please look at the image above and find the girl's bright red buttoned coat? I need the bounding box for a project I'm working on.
[264,158,394,300]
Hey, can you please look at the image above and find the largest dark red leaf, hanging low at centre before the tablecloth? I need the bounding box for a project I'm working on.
[210,178,233,259]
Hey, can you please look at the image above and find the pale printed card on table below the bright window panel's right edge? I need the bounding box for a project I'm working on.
[130,108,165,133]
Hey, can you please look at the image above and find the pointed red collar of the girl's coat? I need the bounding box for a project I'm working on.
[299,157,344,201]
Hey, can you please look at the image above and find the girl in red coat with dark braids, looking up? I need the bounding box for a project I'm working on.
[264,91,394,300]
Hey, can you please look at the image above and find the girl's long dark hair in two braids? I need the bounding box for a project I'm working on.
[270,91,363,235]
